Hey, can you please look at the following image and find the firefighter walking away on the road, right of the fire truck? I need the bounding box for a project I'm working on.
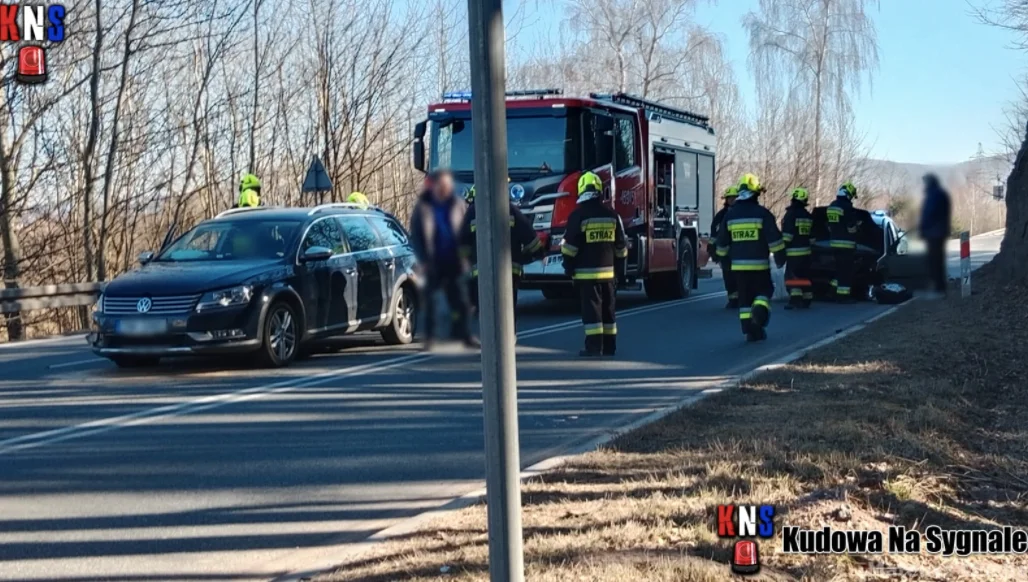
[718,174,785,341]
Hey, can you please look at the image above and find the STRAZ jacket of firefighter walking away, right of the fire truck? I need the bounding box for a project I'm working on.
[718,197,785,270]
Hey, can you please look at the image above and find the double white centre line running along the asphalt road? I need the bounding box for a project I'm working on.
[0,292,725,456]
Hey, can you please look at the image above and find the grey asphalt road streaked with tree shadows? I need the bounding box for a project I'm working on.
[0,237,999,582]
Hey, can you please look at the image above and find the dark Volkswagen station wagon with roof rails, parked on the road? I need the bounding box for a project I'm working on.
[88,204,417,367]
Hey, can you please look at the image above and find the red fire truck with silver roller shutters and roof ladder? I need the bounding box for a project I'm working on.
[413,89,717,299]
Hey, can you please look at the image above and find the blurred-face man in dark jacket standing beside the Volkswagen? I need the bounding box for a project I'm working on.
[410,170,477,350]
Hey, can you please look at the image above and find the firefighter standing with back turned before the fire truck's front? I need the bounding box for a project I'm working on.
[560,172,628,357]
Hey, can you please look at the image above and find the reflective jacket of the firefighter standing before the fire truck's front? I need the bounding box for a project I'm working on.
[560,198,628,281]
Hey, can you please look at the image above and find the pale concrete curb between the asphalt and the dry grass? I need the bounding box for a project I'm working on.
[272,297,918,582]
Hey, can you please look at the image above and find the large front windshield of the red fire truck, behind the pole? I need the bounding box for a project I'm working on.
[430,115,579,179]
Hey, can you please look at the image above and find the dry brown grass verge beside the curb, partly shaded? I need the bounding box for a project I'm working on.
[323,279,1028,582]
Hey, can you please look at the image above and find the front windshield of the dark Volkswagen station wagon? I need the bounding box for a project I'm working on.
[156,220,300,262]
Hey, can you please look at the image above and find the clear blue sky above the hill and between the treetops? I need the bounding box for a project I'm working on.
[522,0,1028,163]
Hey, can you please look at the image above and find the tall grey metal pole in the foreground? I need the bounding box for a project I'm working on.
[468,0,524,582]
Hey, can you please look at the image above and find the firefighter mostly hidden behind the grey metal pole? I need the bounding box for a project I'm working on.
[458,186,545,327]
